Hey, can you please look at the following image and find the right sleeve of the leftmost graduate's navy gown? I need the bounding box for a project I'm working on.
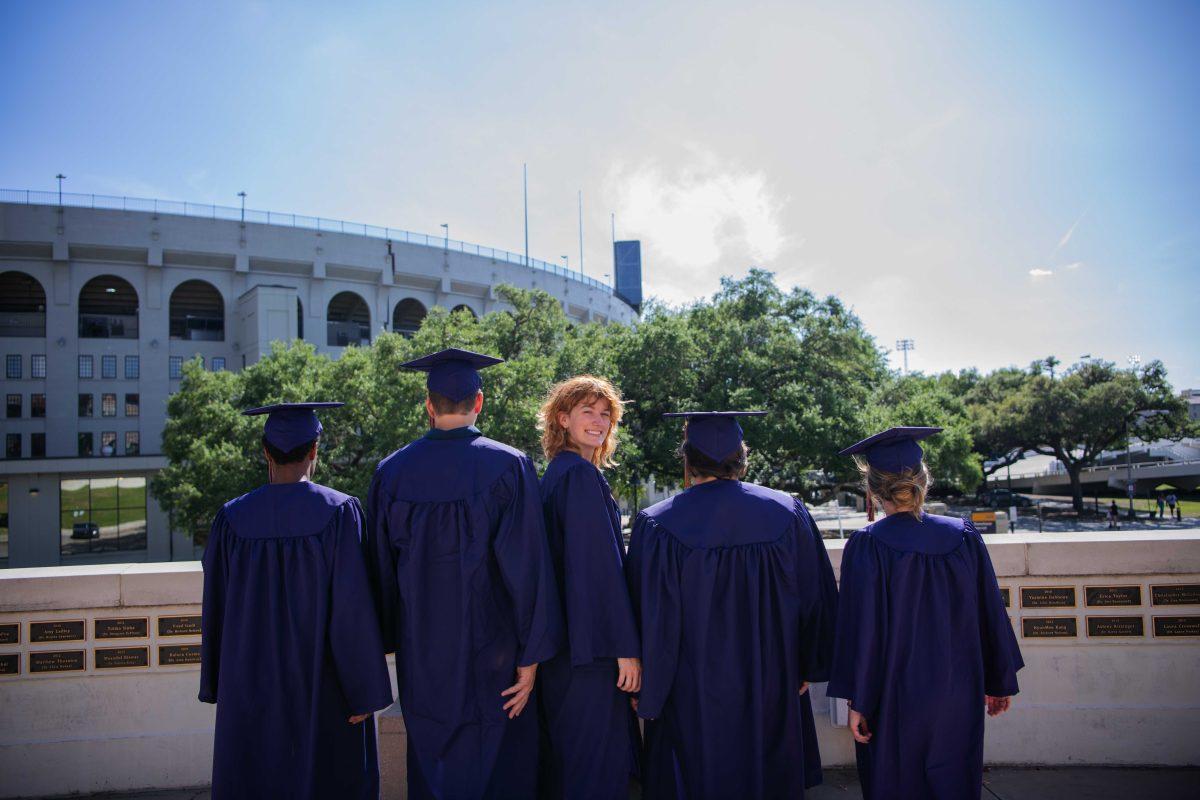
[329,498,392,715]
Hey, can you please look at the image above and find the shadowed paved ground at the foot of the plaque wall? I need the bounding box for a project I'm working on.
[37,766,1200,800]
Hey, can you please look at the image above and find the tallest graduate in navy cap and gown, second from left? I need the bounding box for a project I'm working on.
[367,349,563,800]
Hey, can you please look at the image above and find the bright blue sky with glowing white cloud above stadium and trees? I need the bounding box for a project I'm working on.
[0,1,1200,387]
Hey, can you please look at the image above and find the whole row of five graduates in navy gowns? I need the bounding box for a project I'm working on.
[199,349,1022,800]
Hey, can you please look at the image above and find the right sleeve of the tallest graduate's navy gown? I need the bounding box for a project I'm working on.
[492,458,563,667]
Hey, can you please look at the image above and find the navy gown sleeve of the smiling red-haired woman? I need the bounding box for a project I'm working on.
[553,464,642,666]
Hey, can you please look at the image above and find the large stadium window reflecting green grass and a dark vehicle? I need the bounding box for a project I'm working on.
[59,476,146,555]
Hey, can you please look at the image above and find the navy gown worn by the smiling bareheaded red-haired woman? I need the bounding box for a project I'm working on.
[538,451,642,800]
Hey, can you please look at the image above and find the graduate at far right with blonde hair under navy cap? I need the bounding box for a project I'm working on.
[828,427,1025,800]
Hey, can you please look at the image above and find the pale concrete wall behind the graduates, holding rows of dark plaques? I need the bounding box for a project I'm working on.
[0,533,1200,796]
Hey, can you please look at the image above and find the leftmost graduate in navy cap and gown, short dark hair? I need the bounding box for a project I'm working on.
[199,403,392,800]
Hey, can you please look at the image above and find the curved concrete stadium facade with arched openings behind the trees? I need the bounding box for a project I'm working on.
[0,192,637,567]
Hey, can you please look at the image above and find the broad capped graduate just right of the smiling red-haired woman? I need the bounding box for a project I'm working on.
[626,411,838,799]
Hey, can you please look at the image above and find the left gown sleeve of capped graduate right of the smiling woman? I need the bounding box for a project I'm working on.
[626,515,683,720]
